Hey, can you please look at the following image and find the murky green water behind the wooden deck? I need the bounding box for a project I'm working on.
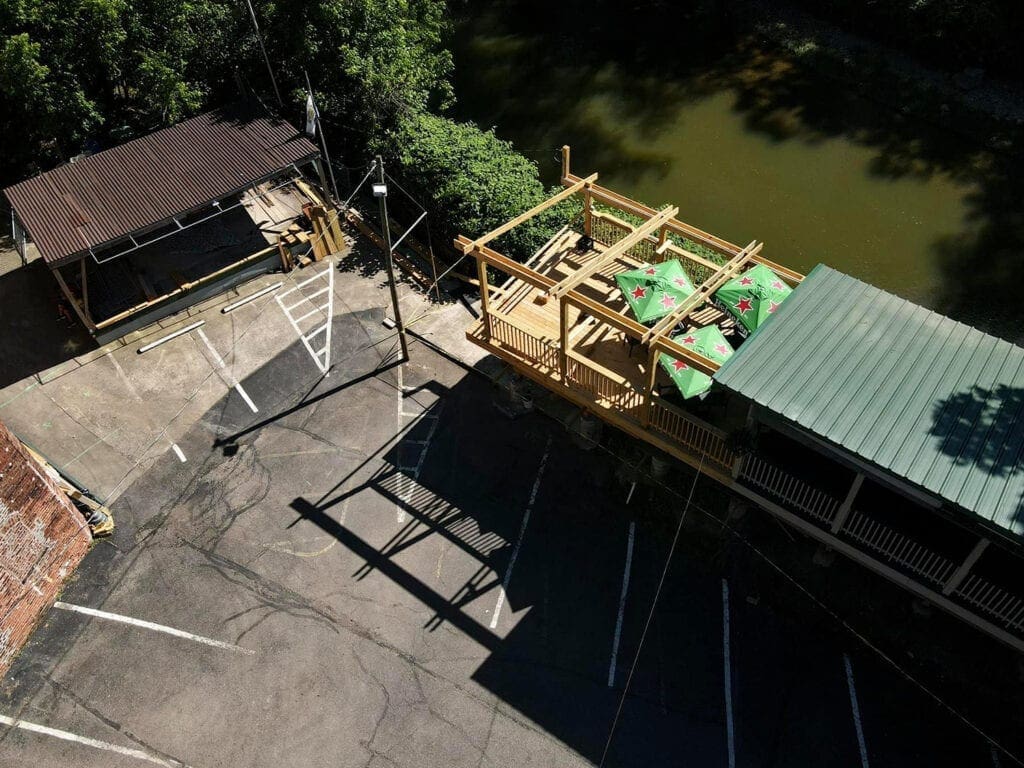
[456,6,1017,336]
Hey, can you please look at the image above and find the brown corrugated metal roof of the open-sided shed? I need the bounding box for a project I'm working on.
[4,106,318,266]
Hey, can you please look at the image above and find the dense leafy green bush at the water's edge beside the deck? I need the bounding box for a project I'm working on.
[394,112,577,259]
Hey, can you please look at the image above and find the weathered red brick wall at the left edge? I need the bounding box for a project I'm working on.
[0,424,92,675]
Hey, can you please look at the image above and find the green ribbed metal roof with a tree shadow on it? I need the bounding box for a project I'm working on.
[715,264,1024,536]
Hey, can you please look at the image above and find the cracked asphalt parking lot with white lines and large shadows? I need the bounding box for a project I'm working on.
[0,253,1013,768]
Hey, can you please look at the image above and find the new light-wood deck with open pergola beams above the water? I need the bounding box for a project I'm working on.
[456,152,803,482]
